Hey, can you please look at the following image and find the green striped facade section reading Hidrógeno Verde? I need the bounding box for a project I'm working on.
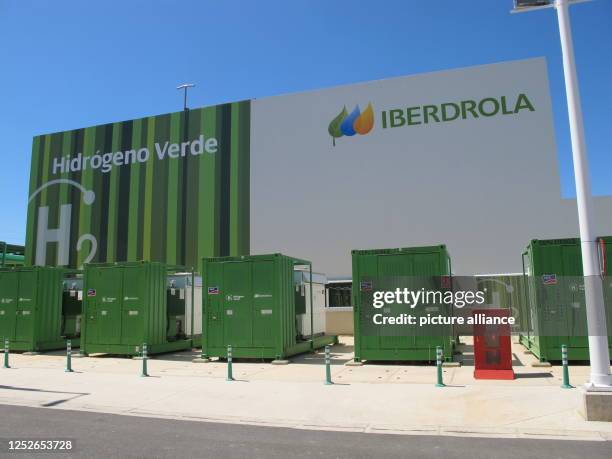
[26,101,251,268]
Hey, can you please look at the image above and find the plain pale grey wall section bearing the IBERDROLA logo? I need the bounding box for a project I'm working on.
[251,58,612,275]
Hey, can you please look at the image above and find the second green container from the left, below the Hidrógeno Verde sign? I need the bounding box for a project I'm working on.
[81,262,191,355]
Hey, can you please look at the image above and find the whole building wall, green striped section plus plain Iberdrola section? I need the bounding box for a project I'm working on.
[26,58,612,275]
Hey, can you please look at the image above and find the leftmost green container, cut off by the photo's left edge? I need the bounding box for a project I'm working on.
[0,267,81,352]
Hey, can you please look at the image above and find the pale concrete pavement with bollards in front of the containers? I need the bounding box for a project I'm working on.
[0,337,612,440]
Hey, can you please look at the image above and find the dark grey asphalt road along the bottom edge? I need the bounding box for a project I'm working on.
[0,405,612,459]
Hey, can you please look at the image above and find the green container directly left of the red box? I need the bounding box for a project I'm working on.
[352,245,453,362]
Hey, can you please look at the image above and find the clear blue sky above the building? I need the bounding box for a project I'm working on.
[0,0,612,242]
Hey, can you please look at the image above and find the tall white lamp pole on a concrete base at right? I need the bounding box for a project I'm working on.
[555,0,612,389]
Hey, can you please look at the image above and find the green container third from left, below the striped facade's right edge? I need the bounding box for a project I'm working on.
[202,254,336,360]
